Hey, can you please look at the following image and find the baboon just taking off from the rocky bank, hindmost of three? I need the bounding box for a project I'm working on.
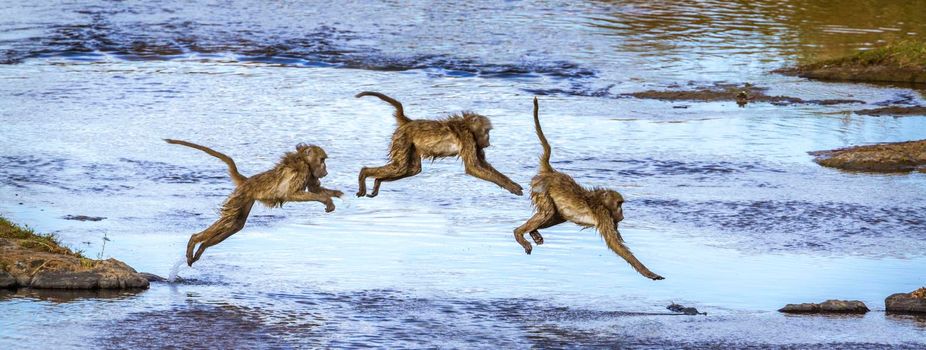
[164,139,344,266]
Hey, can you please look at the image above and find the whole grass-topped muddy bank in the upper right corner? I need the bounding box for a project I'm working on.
[772,41,926,83]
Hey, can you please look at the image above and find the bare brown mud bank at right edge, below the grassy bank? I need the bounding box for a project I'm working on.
[810,140,926,172]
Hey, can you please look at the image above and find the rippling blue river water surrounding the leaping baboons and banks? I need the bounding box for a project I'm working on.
[0,1,926,348]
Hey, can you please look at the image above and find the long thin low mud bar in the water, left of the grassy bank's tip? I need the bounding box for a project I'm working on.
[620,84,865,106]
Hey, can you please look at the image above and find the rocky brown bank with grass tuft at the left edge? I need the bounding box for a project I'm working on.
[0,218,148,289]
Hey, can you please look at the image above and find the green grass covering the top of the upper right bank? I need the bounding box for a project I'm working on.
[801,40,926,69]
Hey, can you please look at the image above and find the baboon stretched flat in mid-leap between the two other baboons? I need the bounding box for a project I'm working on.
[355,91,522,197]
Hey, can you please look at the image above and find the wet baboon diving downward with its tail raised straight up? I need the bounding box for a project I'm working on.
[514,97,663,280]
